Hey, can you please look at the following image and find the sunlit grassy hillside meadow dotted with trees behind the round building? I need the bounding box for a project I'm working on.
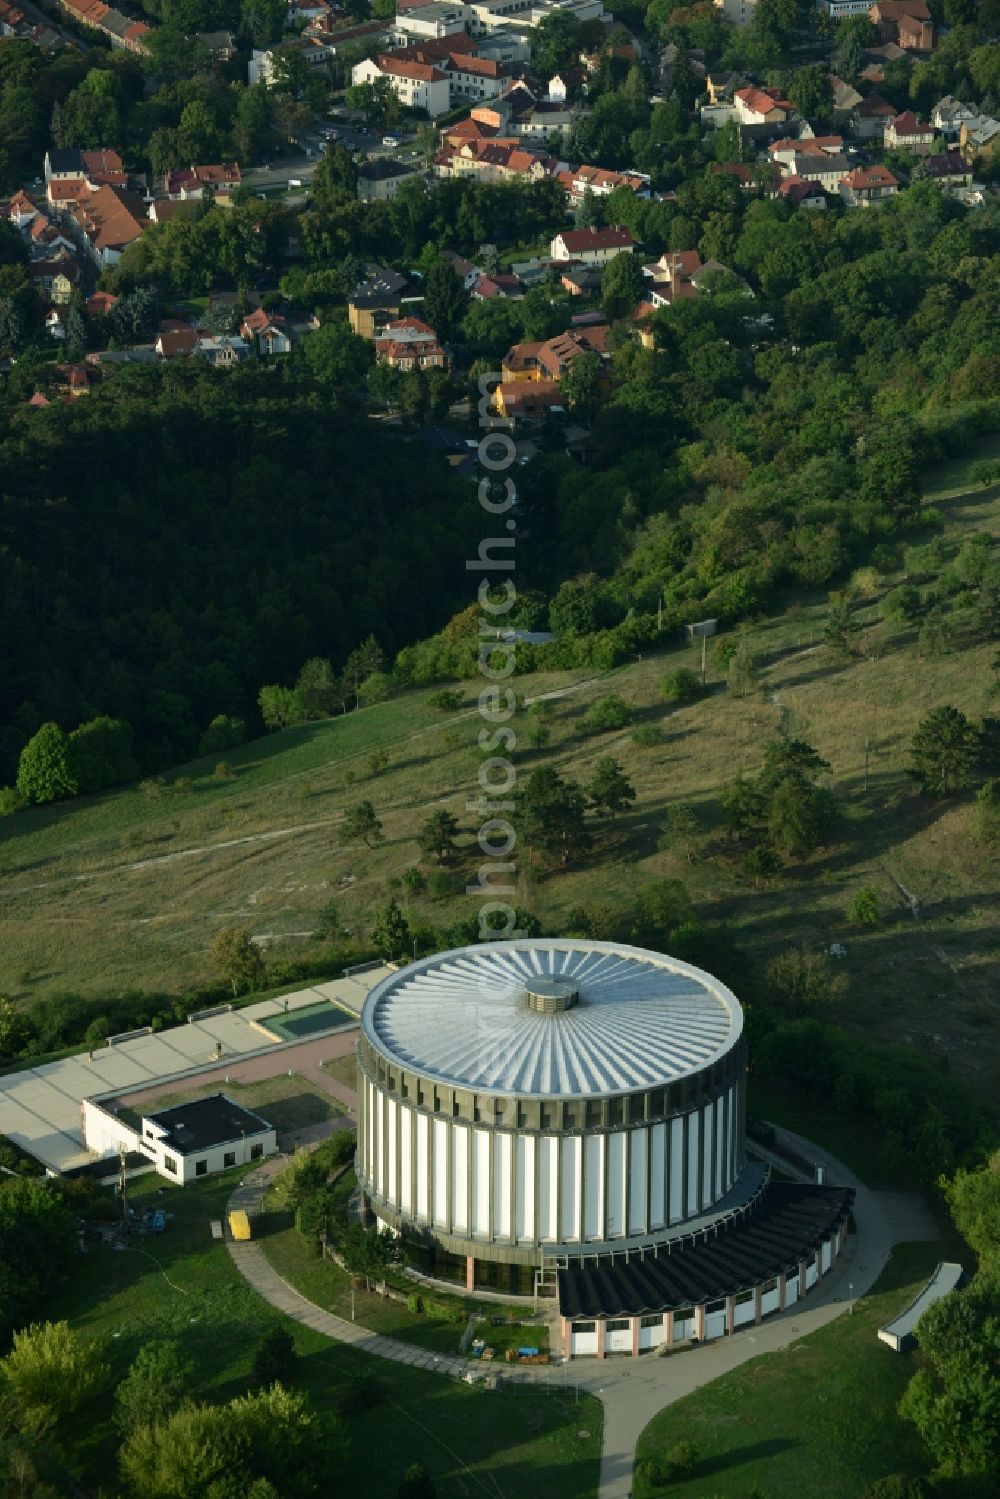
[0,454,1000,1094]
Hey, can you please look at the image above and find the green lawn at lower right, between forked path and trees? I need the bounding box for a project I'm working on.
[633,1243,940,1499]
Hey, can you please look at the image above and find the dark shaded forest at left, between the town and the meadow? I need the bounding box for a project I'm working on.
[0,367,477,779]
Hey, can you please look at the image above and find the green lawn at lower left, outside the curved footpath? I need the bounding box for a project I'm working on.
[48,1171,603,1499]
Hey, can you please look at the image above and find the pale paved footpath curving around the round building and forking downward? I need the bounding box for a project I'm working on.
[228,1130,928,1499]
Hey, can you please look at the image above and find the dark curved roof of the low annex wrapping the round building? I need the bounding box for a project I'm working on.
[559,1181,855,1318]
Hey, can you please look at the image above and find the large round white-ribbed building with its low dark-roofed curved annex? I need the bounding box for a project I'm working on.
[358,938,850,1355]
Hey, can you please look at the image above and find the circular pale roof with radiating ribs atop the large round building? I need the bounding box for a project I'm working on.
[361,938,744,1097]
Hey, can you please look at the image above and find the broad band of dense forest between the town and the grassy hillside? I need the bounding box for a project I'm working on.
[0,185,1000,781]
